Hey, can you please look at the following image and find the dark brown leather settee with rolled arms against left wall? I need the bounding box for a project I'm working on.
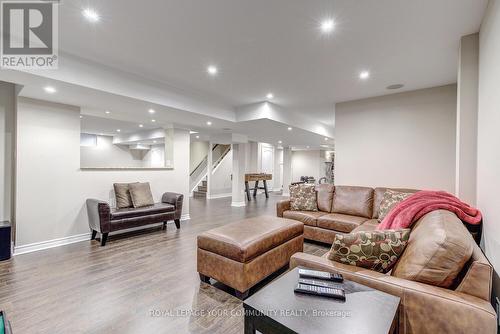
[87,192,184,246]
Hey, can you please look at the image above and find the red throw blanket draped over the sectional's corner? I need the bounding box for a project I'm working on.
[377,190,482,230]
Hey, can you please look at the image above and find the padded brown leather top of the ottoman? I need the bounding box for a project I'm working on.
[198,216,304,263]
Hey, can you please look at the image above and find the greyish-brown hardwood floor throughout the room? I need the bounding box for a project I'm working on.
[0,194,328,334]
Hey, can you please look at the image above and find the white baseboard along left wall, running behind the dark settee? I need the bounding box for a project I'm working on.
[13,213,191,255]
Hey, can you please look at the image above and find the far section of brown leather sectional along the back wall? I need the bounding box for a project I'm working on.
[277,184,417,244]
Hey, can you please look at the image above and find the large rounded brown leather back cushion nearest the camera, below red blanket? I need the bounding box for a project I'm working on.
[392,210,474,288]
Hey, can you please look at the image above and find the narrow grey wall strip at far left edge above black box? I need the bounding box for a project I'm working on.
[0,81,16,221]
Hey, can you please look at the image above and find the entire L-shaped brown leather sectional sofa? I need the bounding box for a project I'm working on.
[278,186,497,334]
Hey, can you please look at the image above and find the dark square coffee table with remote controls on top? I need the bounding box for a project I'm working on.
[243,268,400,334]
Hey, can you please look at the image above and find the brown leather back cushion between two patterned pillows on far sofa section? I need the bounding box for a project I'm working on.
[332,186,373,218]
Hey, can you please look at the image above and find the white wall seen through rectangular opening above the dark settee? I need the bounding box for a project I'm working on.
[80,136,165,167]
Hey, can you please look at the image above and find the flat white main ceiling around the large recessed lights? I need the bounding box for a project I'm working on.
[59,0,487,124]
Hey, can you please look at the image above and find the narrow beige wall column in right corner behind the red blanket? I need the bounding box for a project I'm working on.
[455,33,479,205]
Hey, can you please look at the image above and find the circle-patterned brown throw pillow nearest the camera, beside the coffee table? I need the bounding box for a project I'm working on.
[328,229,410,273]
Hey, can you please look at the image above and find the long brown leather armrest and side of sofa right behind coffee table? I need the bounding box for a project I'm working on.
[290,253,497,333]
